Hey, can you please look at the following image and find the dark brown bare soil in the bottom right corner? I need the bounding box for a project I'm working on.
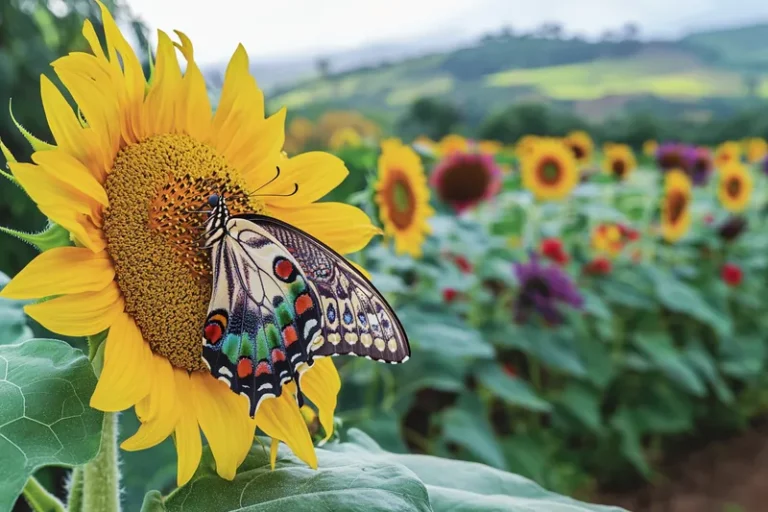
[591,424,768,512]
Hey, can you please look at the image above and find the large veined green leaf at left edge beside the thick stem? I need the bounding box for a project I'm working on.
[0,339,103,510]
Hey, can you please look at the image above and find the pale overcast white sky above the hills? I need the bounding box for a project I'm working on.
[126,0,768,64]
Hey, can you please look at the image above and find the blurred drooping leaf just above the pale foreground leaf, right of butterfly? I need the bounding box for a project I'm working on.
[442,395,507,469]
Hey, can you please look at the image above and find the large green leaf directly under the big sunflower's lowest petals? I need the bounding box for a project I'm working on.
[161,432,432,512]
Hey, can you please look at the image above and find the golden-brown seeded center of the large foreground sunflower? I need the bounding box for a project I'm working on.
[104,134,264,371]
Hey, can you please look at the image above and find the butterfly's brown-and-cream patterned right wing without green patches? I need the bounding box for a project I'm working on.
[240,215,411,363]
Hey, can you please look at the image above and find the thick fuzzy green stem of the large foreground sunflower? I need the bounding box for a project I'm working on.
[83,412,120,512]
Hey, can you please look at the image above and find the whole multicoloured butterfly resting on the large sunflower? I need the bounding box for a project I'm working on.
[203,194,410,417]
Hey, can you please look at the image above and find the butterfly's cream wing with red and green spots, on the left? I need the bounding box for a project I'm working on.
[203,218,322,416]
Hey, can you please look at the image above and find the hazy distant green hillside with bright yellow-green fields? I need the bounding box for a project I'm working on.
[273,25,768,123]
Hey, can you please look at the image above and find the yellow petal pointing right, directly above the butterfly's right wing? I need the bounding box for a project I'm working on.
[270,203,381,254]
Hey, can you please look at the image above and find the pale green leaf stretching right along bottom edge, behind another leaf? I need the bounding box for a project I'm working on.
[336,429,623,512]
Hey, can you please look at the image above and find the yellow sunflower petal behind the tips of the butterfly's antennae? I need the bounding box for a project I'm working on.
[258,151,349,207]
